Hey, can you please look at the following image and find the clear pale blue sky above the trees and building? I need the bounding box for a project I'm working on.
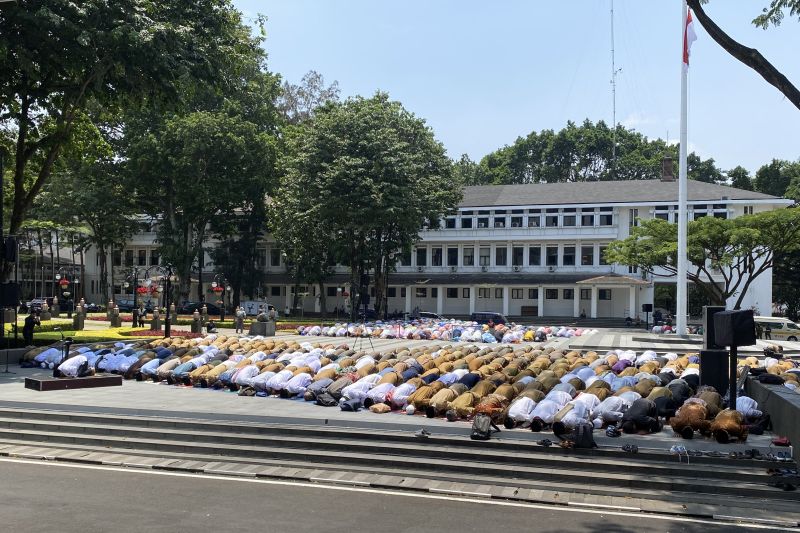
[234,0,800,172]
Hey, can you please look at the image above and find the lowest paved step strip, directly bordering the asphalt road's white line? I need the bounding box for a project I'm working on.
[0,441,797,526]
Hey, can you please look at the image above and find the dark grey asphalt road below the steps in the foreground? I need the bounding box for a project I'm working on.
[0,460,780,533]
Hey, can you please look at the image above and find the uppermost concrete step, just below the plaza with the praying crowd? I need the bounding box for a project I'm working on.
[0,417,780,483]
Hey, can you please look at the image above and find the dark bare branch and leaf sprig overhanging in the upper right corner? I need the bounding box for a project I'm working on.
[687,0,800,109]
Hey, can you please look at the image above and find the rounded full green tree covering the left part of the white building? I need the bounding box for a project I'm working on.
[285,93,461,315]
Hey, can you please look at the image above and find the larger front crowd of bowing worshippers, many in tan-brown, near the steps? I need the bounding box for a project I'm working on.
[21,335,800,443]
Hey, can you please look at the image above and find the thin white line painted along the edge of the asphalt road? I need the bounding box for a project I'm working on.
[0,457,798,532]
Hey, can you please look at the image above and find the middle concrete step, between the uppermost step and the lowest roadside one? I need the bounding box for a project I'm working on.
[0,428,800,501]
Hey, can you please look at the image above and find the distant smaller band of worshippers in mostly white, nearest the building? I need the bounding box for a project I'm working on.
[297,319,597,344]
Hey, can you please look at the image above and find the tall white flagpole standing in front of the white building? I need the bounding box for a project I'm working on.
[675,0,689,335]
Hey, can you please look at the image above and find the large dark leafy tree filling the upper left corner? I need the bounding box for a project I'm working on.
[0,0,258,256]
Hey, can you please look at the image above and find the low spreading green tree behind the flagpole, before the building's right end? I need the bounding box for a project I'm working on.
[606,209,800,309]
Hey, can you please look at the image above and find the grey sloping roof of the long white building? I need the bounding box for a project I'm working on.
[459,180,779,208]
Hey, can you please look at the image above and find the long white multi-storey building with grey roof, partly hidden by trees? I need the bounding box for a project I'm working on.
[87,180,791,318]
